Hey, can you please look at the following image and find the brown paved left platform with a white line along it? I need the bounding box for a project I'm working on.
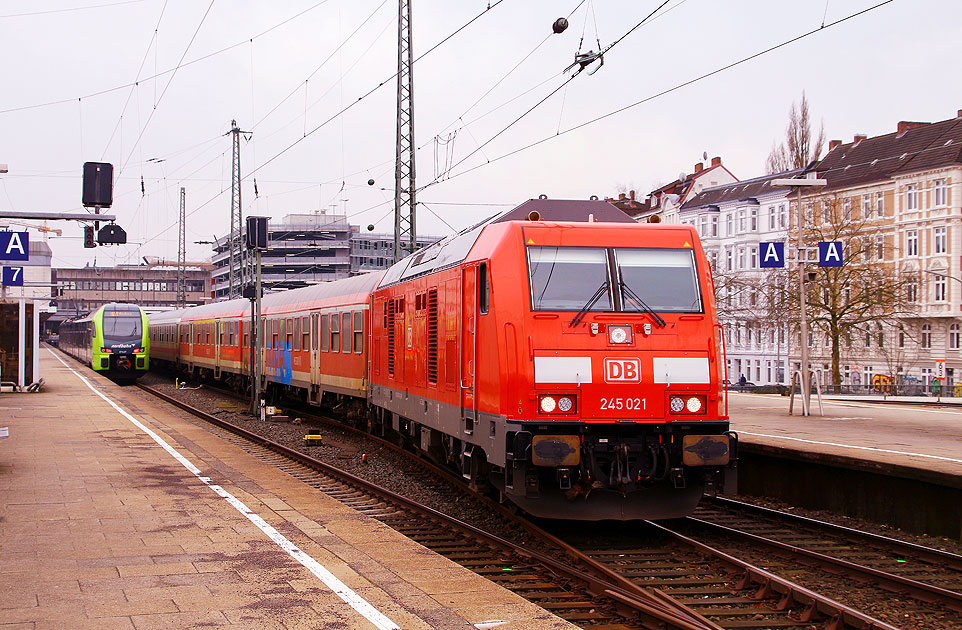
[0,349,575,630]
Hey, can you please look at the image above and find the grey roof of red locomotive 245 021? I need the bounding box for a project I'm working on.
[379,199,637,287]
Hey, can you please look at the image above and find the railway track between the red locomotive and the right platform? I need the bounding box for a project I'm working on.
[687,498,962,612]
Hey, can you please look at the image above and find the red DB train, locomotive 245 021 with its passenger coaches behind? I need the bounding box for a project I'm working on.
[151,199,737,520]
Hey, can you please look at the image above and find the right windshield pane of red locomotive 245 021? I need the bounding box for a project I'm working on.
[615,248,702,313]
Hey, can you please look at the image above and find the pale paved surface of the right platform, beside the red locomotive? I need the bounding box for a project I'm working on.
[729,393,962,478]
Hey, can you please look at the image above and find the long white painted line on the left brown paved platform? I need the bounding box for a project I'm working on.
[47,348,400,630]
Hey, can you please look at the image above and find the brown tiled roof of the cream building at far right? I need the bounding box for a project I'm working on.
[815,112,962,189]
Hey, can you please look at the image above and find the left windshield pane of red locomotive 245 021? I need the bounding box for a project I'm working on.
[528,247,611,311]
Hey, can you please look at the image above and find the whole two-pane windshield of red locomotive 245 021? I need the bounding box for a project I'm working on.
[527,247,703,313]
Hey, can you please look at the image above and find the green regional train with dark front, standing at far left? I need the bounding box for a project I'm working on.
[59,302,150,380]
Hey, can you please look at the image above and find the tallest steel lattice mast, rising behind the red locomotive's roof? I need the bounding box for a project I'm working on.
[394,0,417,262]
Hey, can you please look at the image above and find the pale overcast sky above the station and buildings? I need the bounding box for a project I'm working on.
[0,0,962,267]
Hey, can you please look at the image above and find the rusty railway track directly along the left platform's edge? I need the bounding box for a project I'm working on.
[138,383,718,630]
